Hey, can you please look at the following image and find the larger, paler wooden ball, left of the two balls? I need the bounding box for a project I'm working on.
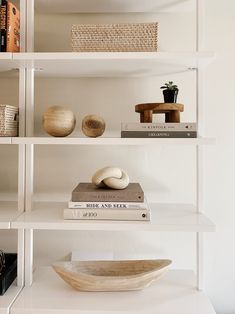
[42,106,76,137]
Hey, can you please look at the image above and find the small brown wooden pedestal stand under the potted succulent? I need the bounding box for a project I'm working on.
[135,103,184,123]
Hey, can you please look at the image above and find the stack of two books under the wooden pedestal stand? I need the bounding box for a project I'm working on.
[121,122,197,138]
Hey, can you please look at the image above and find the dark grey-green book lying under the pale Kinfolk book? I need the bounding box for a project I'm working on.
[121,131,197,138]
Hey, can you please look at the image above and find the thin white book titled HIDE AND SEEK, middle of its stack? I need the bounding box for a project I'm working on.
[68,201,147,209]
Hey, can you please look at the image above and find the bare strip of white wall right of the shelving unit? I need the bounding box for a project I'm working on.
[205,0,235,314]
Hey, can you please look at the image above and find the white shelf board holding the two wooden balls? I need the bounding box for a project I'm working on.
[12,137,215,146]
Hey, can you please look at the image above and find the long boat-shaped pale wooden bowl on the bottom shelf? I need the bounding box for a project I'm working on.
[52,260,171,291]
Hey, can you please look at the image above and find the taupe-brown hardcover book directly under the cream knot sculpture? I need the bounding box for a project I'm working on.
[72,183,144,202]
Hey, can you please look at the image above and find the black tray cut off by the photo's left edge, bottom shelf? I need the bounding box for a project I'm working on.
[0,253,17,295]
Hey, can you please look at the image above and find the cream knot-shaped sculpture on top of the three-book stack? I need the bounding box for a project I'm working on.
[91,167,130,190]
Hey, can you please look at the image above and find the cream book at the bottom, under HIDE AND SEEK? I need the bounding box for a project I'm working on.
[64,208,150,221]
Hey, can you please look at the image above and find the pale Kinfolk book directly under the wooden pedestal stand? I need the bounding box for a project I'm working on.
[121,122,197,132]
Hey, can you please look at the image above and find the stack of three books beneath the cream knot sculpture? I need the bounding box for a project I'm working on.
[64,183,150,221]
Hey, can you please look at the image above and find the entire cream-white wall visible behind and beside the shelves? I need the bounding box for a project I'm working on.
[0,0,235,314]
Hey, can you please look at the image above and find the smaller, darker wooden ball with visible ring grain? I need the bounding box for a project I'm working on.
[82,114,105,137]
